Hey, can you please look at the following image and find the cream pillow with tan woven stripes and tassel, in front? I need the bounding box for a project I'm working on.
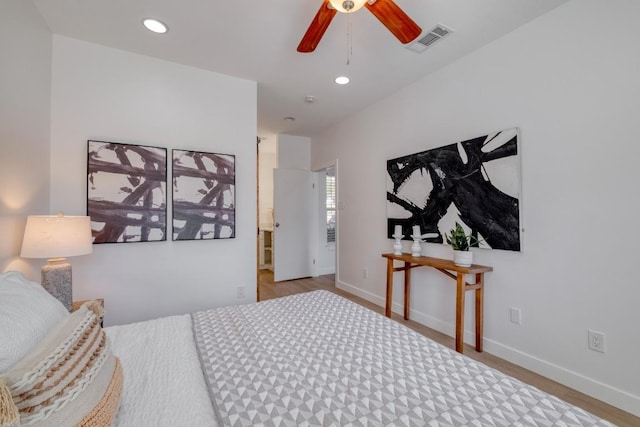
[0,301,123,427]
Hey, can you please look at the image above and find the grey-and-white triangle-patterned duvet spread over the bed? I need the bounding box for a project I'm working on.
[192,291,611,427]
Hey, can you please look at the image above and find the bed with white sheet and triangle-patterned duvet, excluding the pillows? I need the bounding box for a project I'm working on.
[0,272,612,427]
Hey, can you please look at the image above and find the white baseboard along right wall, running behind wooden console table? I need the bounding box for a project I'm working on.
[336,281,640,416]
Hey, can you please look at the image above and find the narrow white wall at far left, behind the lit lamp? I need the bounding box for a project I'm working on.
[0,0,51,282]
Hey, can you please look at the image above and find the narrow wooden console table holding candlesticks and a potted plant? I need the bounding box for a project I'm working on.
[382,253,493,353]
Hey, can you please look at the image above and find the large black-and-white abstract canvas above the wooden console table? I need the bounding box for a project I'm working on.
[387,128,522,251]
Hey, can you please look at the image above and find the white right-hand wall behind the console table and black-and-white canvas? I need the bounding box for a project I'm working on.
[312,0,640,415]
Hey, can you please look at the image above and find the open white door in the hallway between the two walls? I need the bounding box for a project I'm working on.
[273,169,313,282]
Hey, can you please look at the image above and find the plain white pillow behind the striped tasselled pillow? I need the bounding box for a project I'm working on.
[0,271,69,374]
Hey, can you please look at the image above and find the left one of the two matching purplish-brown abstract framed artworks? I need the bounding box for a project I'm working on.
[87,141,167,243]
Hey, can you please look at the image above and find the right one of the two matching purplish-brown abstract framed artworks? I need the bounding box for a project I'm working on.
[172,150,236,240]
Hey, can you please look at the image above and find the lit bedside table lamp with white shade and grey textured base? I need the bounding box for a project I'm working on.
[20,213,93,311]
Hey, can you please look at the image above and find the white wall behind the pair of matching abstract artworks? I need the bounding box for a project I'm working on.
[51,35,257,325]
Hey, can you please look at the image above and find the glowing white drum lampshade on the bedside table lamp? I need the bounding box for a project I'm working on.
[20,214,93,258]
